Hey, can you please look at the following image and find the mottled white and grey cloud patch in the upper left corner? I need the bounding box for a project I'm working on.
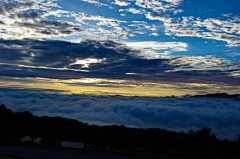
[0,1,83,39]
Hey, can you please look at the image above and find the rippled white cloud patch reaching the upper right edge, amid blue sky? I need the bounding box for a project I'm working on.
[146,12,240,47]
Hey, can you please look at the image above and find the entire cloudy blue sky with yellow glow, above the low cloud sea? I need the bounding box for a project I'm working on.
[0,0,240,96]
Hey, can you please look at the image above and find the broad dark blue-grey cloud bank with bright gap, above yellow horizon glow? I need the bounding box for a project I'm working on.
[0,39,240,94]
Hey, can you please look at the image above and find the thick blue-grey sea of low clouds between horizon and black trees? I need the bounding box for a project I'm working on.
[0,91,240,140]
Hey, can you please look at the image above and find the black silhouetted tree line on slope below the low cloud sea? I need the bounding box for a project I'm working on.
[0,105,240,158]
